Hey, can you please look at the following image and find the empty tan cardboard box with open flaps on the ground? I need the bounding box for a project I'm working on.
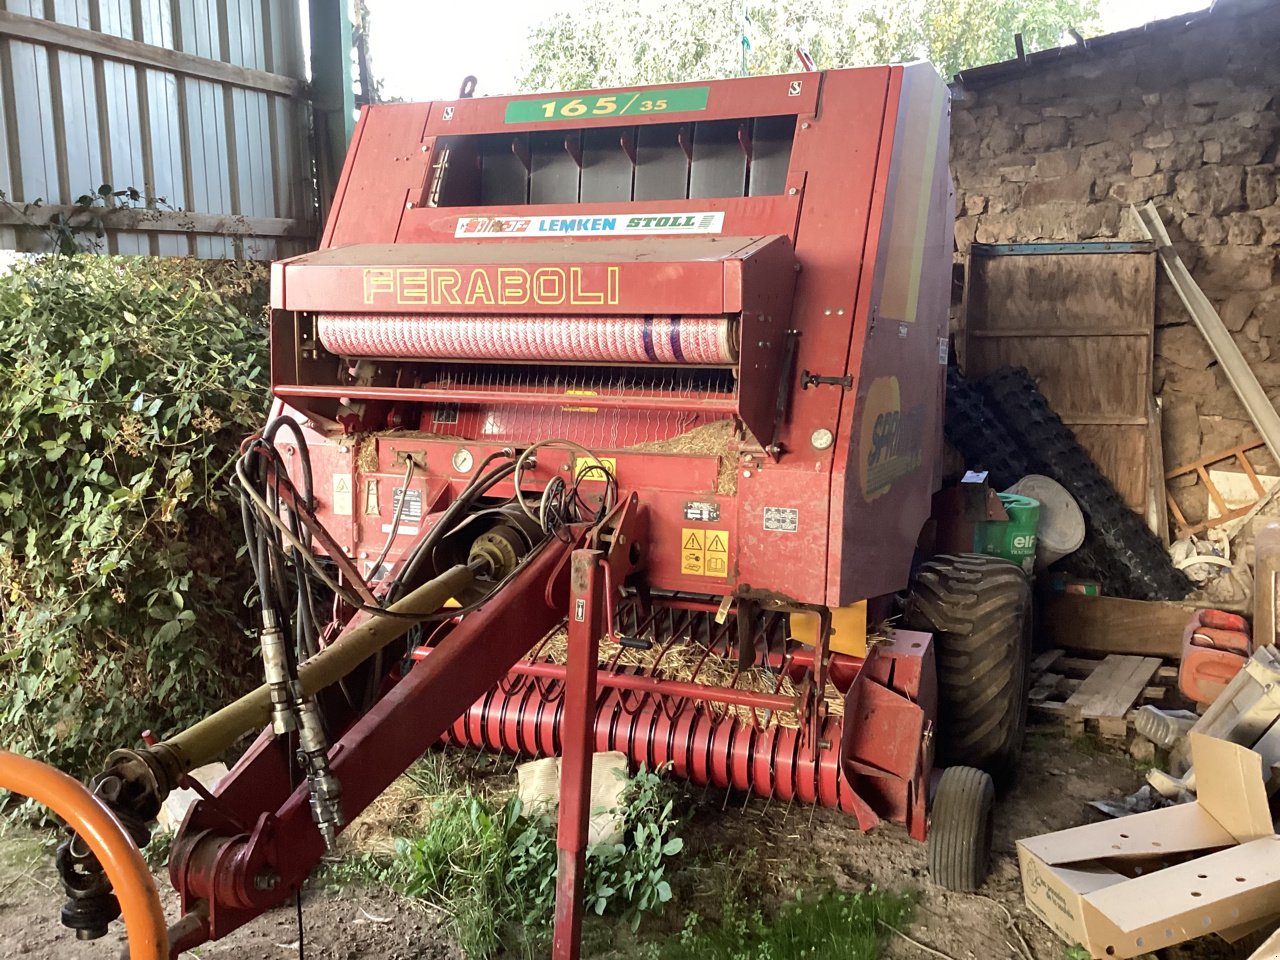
[1018,733,1280,960]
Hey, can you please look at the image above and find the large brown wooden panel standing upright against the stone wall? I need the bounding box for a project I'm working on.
[963,244,1162,516]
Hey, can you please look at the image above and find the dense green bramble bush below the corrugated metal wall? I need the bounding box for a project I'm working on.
[0,256,268,774]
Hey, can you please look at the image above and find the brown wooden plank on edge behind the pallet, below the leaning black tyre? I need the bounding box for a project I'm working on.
[1043,594,1201,659]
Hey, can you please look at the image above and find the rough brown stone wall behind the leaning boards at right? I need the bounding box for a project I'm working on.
[951,0,1280,527]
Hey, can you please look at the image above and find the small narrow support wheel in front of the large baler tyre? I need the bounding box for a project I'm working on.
[927,767,996,892]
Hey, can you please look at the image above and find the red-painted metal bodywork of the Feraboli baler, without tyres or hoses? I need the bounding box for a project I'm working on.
[157,65,951,957]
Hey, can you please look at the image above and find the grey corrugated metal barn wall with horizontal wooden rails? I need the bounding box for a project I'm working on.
[0,0,315,259]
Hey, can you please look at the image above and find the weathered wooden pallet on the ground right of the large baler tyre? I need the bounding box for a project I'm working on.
[1028,650,1178,740]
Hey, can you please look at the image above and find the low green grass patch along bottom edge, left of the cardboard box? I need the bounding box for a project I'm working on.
[650,887,914,960]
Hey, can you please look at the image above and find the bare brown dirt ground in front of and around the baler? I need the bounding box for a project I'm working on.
[0,731,1248,960]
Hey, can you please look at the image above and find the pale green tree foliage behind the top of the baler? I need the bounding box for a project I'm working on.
[521,0,1098,91]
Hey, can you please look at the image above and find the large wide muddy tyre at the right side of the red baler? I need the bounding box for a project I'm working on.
[906,554,1032,785]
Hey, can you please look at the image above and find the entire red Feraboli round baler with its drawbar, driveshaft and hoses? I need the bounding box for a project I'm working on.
[20,65,1024,956]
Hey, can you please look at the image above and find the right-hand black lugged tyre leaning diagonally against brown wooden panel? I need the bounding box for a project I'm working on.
[982,367,1192,600]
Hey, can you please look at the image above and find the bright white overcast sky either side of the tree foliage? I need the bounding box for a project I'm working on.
[366,0,1208,100]
